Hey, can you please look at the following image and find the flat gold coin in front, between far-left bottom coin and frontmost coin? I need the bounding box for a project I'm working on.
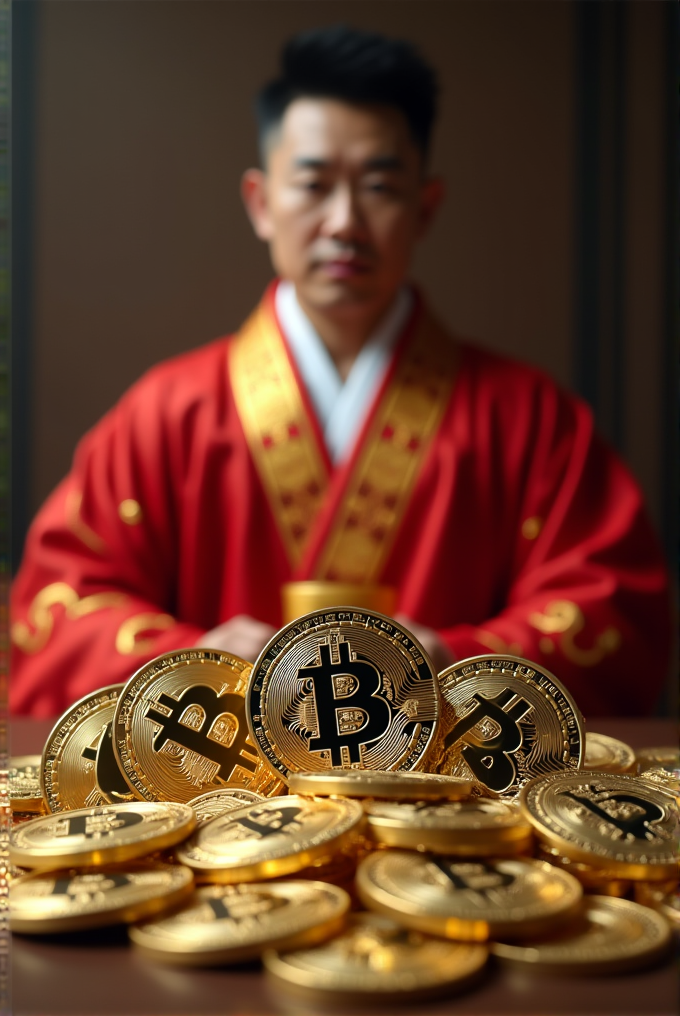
[129,881,350,966]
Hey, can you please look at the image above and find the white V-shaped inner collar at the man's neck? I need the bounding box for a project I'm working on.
[275,281,414,463]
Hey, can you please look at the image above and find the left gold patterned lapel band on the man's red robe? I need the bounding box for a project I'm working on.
[229,307,328,565]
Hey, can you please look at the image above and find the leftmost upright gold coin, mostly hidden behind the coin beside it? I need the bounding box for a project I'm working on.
[41,685,130,812]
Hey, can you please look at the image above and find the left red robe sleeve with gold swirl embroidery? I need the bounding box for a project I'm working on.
[10,365,204,716]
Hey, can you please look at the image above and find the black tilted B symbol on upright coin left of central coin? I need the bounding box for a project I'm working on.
[146,685,257,781]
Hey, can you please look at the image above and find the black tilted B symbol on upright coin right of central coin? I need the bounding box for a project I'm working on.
[444,688,532,793]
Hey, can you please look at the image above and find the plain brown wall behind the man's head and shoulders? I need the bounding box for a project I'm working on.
[30,0,663,548]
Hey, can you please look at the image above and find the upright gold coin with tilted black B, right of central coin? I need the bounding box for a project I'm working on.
[438,656,583,797]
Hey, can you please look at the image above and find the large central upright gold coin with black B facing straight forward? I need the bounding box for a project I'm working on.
[246,608,440,780]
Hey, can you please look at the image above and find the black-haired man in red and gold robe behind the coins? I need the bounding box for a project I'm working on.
[12,28,669,715]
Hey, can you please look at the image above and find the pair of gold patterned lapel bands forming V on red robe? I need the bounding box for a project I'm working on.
[229,290,457,582]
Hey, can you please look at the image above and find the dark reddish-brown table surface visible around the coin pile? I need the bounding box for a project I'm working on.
[11,719,680,1016]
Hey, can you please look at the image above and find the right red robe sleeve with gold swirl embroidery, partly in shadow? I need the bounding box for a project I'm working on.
[440,373,671,715]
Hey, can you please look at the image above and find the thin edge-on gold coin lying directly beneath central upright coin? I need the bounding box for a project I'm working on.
[289,769,473,801]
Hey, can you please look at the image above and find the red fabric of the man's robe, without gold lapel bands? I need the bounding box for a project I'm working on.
[10,290,670,716]
